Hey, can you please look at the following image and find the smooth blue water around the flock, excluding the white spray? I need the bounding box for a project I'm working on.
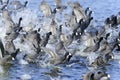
[0,0,120,80]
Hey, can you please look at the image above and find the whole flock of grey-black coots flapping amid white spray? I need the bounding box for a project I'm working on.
[0,0,120,80]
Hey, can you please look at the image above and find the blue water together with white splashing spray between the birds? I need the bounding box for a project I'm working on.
[0,0,120,80]
